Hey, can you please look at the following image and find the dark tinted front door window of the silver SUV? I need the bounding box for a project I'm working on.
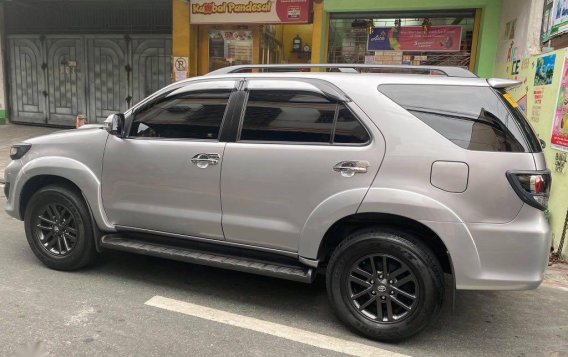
[130,89,231,139]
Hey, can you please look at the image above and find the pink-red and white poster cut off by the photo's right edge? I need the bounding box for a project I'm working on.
[550,56,568,152]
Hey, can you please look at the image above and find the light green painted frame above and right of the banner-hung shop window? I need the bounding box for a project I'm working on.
[322,0,503,77]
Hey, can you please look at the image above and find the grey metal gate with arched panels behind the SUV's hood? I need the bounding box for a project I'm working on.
[8,35,171,126]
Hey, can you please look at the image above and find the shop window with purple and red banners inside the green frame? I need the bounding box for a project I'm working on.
[328,9,480,70]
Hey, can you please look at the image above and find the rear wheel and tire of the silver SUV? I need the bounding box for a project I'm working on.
[326,228,444,342]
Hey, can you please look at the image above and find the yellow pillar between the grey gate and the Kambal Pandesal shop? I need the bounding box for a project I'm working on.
[172,0,197,78]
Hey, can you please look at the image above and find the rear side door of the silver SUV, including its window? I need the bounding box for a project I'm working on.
[221,79,384,252]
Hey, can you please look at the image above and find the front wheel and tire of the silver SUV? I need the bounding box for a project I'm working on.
[24,185,97,271]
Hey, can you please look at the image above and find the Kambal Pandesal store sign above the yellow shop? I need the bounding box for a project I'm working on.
[190,0,311,24]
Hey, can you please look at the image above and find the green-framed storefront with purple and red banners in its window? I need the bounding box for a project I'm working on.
[312,0,502,76]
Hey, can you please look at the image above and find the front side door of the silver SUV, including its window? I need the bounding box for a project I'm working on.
[102,80,236,239]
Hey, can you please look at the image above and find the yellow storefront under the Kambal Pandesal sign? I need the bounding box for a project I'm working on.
[173,0,313,80]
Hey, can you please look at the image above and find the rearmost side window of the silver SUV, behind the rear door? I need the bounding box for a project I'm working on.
[379,85,533,152]
